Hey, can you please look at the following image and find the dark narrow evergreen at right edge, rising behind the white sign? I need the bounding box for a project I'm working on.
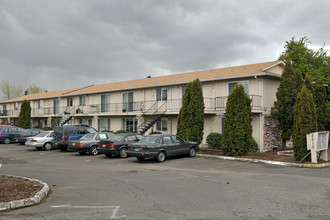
[314,80,330,131]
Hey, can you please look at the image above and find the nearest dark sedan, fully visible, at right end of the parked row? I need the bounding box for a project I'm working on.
[127,134,199,162]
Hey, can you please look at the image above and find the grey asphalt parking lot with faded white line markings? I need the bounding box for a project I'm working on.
[0,144,330,219]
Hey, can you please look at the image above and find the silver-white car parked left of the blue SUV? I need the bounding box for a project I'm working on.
[25,131,54,150]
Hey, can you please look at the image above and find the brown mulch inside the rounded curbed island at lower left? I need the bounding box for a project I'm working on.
[0,176,44,203]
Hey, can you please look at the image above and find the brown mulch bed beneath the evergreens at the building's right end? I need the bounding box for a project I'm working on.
[199,148,328,164]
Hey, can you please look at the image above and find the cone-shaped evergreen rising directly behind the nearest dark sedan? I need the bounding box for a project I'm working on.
[177,79,204,144]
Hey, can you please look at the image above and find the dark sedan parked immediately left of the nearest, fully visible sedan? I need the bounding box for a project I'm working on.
[97,133,143,158]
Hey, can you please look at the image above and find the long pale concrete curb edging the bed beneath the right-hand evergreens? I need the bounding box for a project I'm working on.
[196,154,330,168]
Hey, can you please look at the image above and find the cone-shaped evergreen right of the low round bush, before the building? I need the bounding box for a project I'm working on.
[221,85,253,156]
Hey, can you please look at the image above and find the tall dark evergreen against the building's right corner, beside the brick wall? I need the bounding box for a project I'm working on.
[271,61,302,149]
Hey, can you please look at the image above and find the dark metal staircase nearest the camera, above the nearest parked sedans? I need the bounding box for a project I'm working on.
[137,102,167,135]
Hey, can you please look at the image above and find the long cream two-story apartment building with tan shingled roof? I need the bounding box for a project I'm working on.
[0,61,284,151]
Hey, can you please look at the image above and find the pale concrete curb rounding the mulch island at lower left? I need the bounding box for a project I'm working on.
[0,175,49,212]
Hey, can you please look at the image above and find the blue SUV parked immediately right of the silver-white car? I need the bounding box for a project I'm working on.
[54,125,97,151]
